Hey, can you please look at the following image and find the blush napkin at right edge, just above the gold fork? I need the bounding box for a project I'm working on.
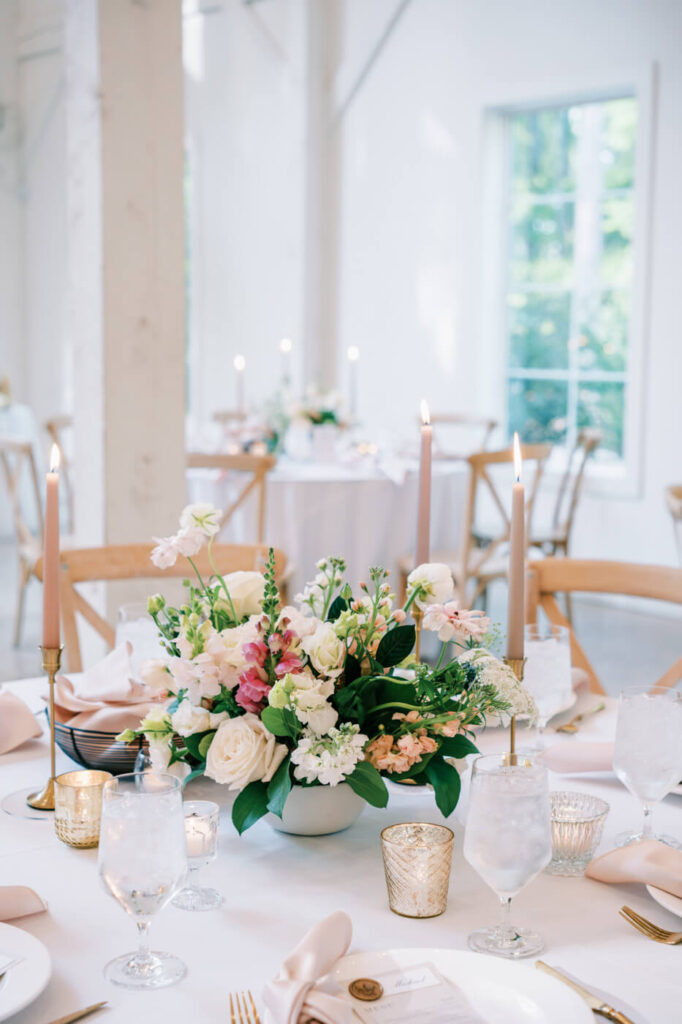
[585,839,682,899]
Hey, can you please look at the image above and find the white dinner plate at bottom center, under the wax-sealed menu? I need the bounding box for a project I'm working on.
[332,949,594,1024]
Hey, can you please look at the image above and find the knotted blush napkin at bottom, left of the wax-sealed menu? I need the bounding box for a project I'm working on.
[263,910,352,1024]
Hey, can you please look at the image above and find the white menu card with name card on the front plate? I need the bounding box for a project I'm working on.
[352,964,485,1024]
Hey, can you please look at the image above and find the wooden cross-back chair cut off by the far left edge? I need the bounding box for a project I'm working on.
[0,437,43,647]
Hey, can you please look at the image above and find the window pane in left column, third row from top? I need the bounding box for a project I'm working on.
[507,292,570,370]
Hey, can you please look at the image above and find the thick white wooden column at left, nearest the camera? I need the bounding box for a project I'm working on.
[66,0,185,545]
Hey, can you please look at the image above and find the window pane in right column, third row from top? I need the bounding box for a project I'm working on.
[579,291,630,372]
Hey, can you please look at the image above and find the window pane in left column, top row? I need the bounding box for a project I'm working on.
[512,108,576,193]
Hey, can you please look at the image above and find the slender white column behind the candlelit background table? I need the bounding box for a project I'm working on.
[303,0,341,388]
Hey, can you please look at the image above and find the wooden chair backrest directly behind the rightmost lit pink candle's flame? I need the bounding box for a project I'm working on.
[460,444,552,601]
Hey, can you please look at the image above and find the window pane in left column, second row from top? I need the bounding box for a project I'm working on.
[511,199,573,286]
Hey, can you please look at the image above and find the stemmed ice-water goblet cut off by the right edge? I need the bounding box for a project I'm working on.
[613,686,682,849]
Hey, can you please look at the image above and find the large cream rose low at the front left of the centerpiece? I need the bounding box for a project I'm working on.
[206,712,287,790]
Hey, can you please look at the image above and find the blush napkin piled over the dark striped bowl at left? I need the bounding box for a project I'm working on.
[54,643,157,733]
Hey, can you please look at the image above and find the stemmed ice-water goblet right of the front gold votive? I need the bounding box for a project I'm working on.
[464,754,552,958]
